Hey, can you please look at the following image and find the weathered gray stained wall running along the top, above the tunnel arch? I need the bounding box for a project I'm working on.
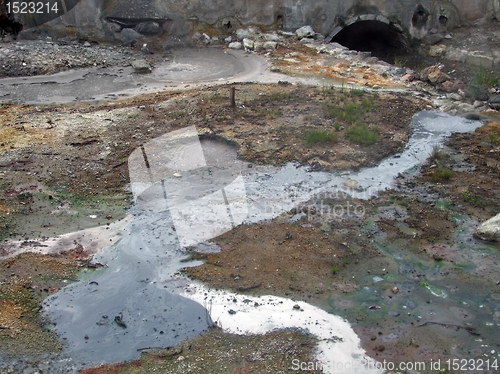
[4,0,500,42]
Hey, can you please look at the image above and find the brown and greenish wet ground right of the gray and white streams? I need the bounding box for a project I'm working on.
[184,118,500,372]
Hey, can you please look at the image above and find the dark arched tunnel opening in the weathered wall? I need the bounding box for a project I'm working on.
[331,21,409,64]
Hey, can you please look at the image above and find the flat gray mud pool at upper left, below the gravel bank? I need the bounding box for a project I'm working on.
[0,48,266,104]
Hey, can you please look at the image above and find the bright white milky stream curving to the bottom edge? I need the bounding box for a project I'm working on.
[182,282,382,374]
